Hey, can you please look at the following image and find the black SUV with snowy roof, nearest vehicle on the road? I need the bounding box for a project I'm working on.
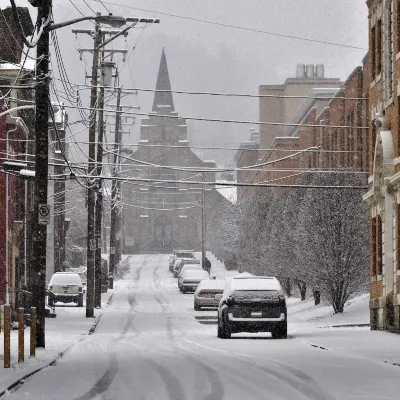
[215,277,287,339]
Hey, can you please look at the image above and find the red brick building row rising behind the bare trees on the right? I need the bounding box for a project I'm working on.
[235,62,368,201]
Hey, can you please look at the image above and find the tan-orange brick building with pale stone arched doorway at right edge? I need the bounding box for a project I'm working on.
[364,0,400,333]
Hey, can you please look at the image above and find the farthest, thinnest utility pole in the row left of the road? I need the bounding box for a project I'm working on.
[108,88,121,289]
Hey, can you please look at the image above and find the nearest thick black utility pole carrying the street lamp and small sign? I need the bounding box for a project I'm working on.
[32,0,52,347]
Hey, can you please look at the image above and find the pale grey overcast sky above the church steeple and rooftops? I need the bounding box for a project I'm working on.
[0,0,368,163]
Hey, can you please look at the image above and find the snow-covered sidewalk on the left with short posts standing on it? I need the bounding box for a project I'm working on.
[0,290,114,396]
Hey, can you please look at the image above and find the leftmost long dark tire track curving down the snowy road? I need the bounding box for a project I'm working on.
[74,257,148,400]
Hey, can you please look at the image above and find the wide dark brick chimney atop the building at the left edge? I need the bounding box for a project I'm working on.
[0,7,34,64]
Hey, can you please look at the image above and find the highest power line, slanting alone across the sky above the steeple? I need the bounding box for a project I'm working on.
[87,0,368,51]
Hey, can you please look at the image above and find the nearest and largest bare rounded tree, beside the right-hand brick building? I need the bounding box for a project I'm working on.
[294,173,369,313]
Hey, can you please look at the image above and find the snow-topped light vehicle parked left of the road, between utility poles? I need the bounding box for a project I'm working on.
[48,272,83,307]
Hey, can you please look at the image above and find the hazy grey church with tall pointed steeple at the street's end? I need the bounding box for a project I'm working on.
[120,50,218,254]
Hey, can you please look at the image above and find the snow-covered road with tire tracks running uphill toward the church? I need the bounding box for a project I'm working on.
[7,255,400,400]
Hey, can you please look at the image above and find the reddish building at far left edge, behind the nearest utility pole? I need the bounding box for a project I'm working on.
[0,7,34,306]
